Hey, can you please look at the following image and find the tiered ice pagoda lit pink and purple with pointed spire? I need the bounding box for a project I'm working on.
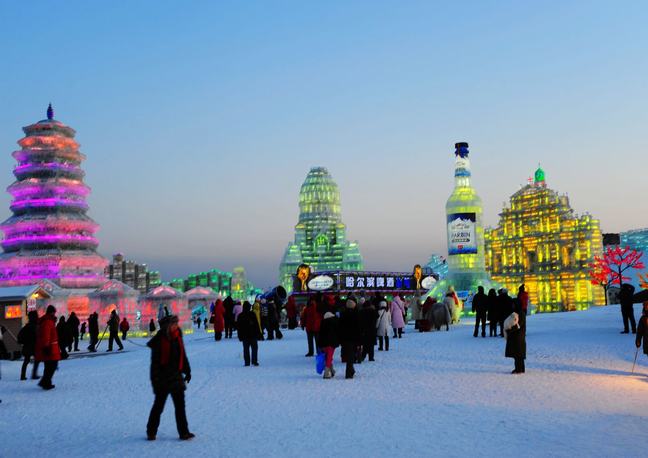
[0,104,108,289]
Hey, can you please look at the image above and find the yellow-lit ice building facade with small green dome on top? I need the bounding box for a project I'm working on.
[485,168,604,312]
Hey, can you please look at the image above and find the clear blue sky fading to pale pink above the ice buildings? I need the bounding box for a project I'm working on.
[0,1,648,286]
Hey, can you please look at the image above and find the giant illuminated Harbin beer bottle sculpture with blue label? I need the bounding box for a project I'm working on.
[433,142,491,296]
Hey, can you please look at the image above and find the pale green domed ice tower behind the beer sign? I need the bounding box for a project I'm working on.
[279,167,363,291]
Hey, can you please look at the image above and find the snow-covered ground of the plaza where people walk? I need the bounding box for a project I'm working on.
[0,306,648,457]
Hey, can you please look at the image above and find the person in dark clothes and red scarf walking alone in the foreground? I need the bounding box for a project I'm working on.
[146,315,195,440]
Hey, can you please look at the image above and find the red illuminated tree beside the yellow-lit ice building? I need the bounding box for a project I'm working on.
[589,246,644,305]
